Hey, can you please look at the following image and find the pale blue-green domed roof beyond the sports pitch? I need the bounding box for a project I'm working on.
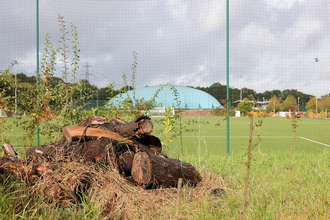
[110,85,223,109]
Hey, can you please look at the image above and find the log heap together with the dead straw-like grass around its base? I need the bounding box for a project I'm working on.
[0,116,225,219]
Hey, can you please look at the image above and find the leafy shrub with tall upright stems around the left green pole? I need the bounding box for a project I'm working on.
[16,15,91,146]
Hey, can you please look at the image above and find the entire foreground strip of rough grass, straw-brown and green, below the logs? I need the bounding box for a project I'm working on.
[0,151,330,219]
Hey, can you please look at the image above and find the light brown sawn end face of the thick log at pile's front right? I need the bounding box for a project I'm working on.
[132,151,152,185]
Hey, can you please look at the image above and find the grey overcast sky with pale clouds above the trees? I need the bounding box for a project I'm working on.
[0,0,330,97]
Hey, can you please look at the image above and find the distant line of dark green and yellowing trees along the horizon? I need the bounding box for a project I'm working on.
[0,73,330,111]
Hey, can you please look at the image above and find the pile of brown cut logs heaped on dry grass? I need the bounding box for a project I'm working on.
[0,116,201,199]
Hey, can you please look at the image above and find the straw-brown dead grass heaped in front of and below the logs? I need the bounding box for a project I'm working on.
[0,151,229,219]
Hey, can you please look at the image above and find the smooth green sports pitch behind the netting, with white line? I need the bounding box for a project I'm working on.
[4,117,330,156]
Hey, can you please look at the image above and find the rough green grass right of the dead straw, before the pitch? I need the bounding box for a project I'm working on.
[182,151,330,219]
